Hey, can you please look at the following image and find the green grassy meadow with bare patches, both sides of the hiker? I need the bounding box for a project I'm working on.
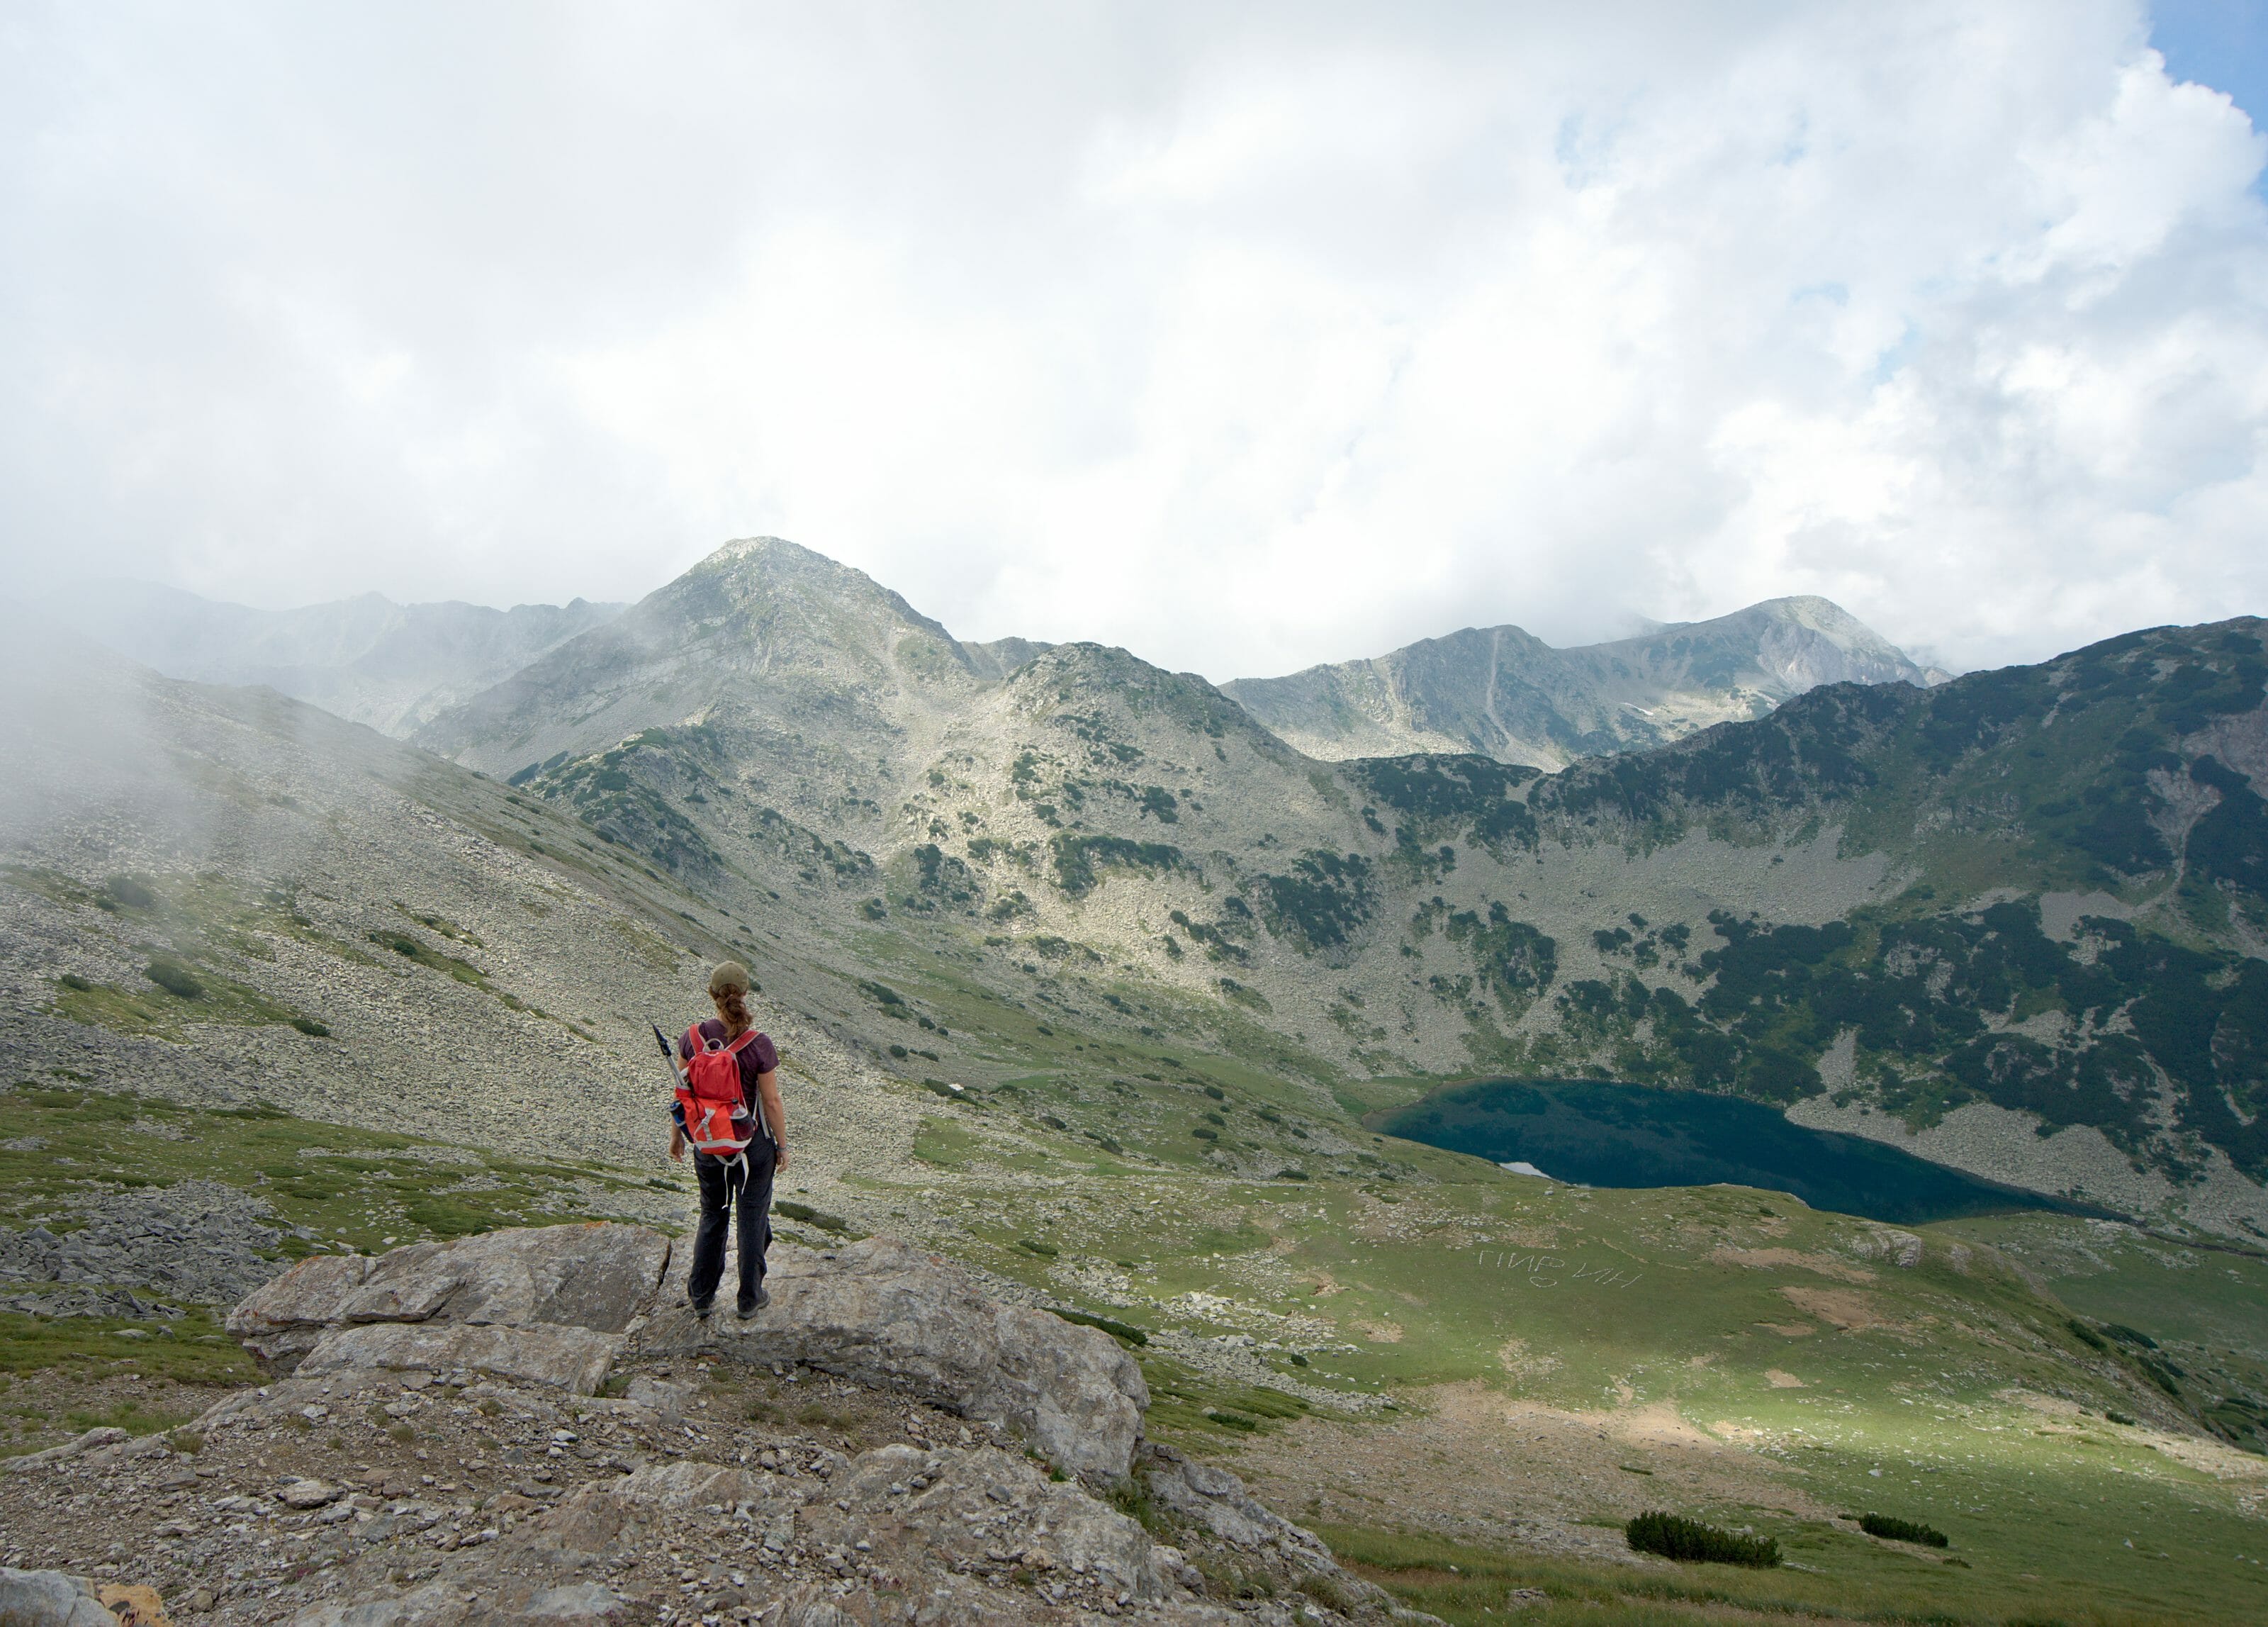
[0,1048,2268,1625]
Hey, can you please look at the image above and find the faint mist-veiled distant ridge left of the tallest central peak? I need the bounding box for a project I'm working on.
[55,581,622,739]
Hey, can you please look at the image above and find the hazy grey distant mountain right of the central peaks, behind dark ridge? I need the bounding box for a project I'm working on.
[1220,597,1948,769]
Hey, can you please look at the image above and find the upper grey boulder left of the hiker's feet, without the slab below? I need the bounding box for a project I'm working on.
[229,1221,669,1366]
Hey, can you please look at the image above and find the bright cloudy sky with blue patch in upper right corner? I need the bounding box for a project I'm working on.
[0,0,2268,678]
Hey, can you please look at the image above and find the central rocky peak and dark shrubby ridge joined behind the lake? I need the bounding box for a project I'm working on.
[4,540,2268,1234]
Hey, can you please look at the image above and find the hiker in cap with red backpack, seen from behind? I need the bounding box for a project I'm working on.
[669,960,787,1319]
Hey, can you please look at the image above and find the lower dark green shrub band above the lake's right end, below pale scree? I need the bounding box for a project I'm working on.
[1529,901,2268,1178]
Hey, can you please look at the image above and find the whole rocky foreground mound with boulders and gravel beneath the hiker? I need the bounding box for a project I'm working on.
[0,1228,1429,1627]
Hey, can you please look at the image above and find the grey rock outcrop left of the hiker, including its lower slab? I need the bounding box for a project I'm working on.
[229,1223,669,1393]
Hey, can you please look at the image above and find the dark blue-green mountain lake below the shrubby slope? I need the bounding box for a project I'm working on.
[1368,1080,2107,1223]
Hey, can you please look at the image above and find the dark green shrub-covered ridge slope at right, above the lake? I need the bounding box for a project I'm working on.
[1347,622,2268,1180]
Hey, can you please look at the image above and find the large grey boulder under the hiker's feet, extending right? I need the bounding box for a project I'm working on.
[639,1236,1150,1484]
